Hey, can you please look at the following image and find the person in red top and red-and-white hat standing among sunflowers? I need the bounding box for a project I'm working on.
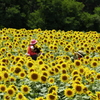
[26,39,42,60]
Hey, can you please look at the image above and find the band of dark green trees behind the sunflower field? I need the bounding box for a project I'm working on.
[0,0,100,32]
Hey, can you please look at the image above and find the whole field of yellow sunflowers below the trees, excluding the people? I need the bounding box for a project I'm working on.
[0,28,100,100]
